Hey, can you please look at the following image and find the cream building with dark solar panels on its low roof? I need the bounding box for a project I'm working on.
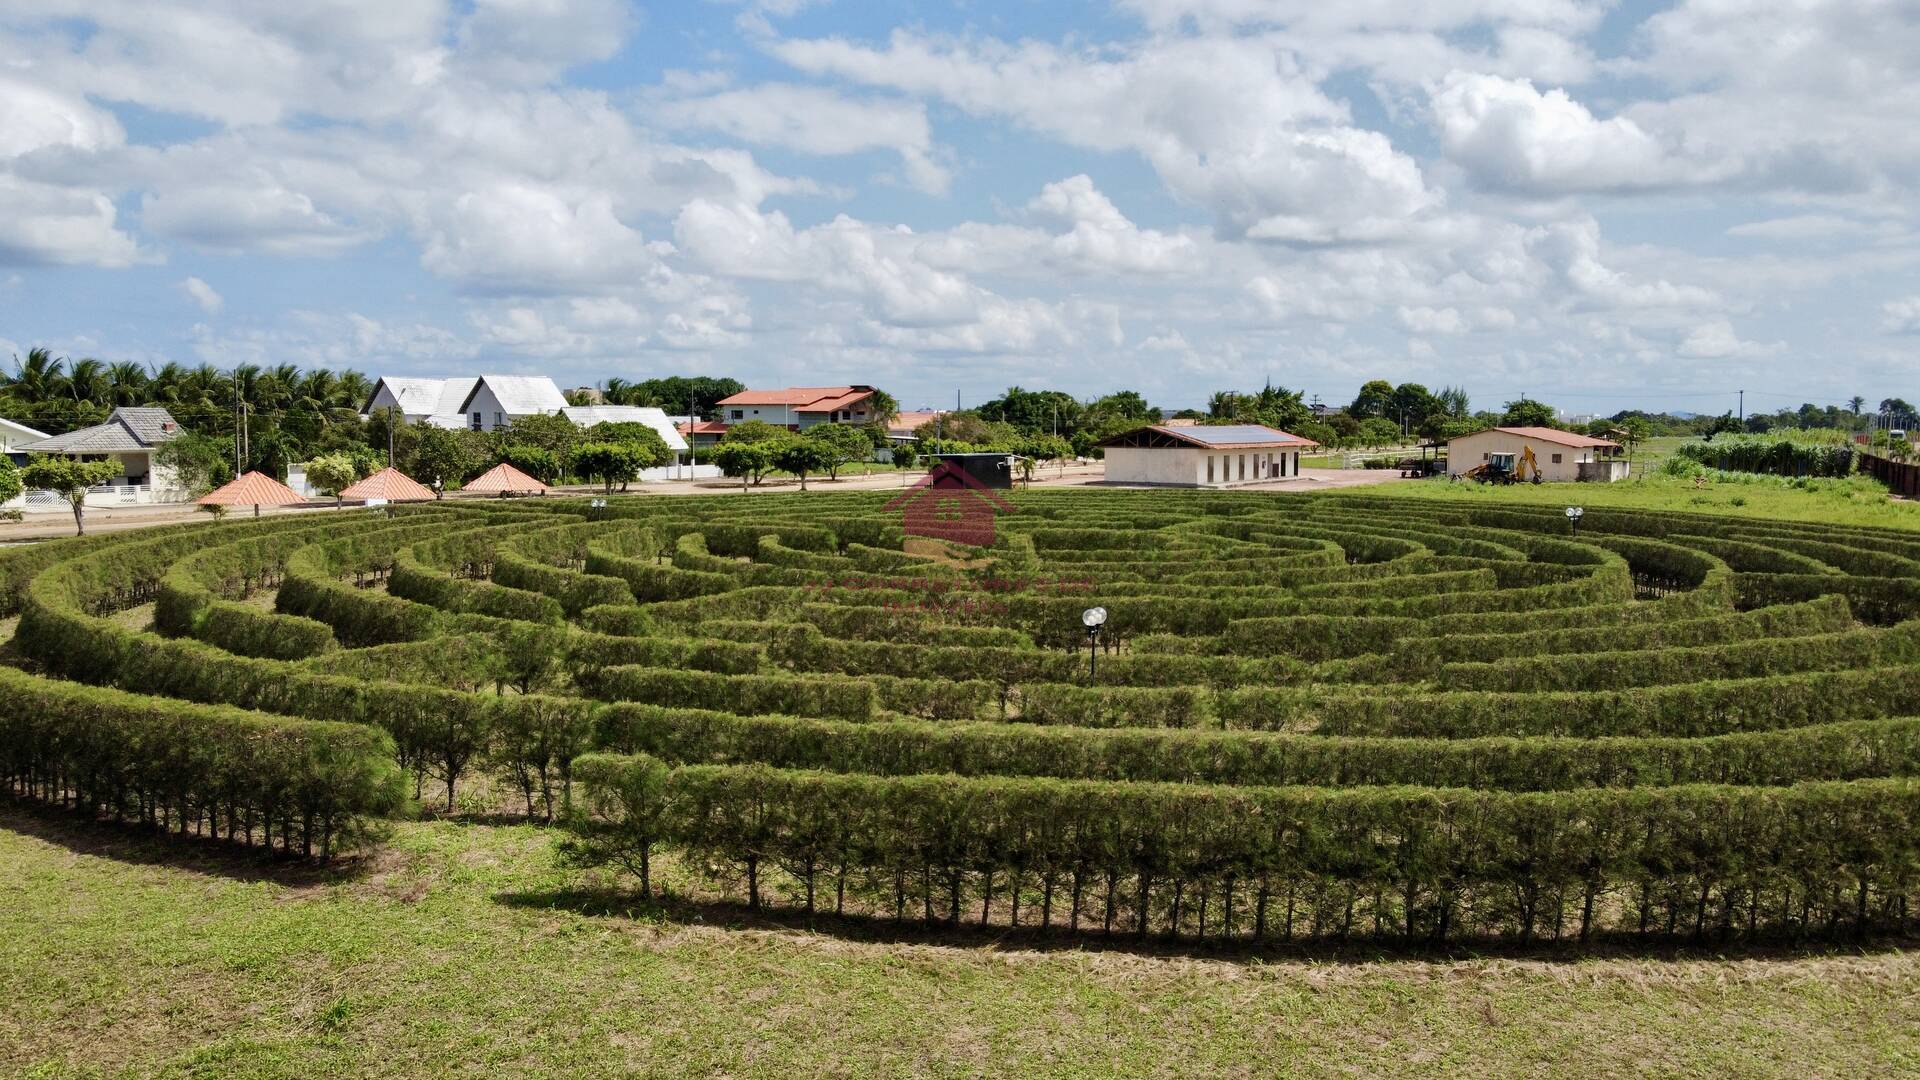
[1100,425,1319,488]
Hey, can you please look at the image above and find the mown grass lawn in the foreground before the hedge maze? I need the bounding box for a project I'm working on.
[0,805,1920,1076]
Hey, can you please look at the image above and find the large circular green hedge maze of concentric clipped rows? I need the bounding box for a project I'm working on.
[0,492,1920,947]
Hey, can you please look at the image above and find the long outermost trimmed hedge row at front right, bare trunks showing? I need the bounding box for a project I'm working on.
[568,755,1920,944]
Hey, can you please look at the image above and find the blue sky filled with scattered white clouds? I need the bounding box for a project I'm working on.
[0,0,1920,413]
